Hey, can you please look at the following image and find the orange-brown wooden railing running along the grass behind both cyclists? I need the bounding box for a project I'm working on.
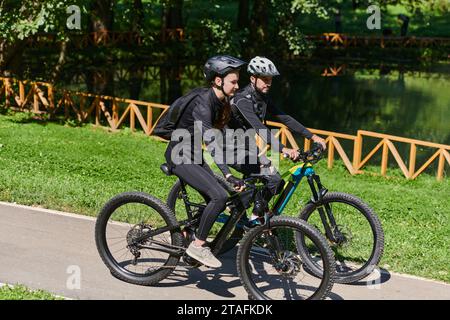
[0,77,450,180]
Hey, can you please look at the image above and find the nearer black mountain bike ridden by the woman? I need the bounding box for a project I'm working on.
[95,165,336,300]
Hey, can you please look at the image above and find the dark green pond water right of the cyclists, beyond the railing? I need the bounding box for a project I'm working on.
[274,63,450,145]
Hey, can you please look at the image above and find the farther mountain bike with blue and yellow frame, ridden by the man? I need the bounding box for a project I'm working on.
[167,144,384,283]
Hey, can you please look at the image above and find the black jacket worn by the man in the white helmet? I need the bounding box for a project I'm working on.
[228,84,313,152]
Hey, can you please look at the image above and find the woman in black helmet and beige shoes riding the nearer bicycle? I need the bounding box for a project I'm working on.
[165,55,245,268]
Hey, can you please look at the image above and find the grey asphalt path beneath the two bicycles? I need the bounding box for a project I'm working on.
[0,202,450,300]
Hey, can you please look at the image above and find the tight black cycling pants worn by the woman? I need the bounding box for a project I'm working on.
[172,164,228,241]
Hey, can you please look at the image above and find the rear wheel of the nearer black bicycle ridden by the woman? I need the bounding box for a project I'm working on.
[95,192,183,285]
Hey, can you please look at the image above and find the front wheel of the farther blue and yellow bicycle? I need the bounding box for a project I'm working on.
[298,192,384,283]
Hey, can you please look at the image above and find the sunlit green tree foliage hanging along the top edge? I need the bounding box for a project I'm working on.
[0,0,450,76]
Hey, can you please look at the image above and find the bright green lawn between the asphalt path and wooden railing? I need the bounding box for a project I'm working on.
[0,110,450,282]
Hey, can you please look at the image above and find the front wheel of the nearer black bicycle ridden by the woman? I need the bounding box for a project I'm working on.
[237,216,335,300]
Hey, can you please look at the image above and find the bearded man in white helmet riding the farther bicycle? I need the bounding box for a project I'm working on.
[226,56,326,225]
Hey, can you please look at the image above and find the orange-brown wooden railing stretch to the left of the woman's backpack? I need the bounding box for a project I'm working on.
[0,78,168,135]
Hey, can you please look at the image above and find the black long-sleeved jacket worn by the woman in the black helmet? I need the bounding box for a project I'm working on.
[165,88,230,175]
